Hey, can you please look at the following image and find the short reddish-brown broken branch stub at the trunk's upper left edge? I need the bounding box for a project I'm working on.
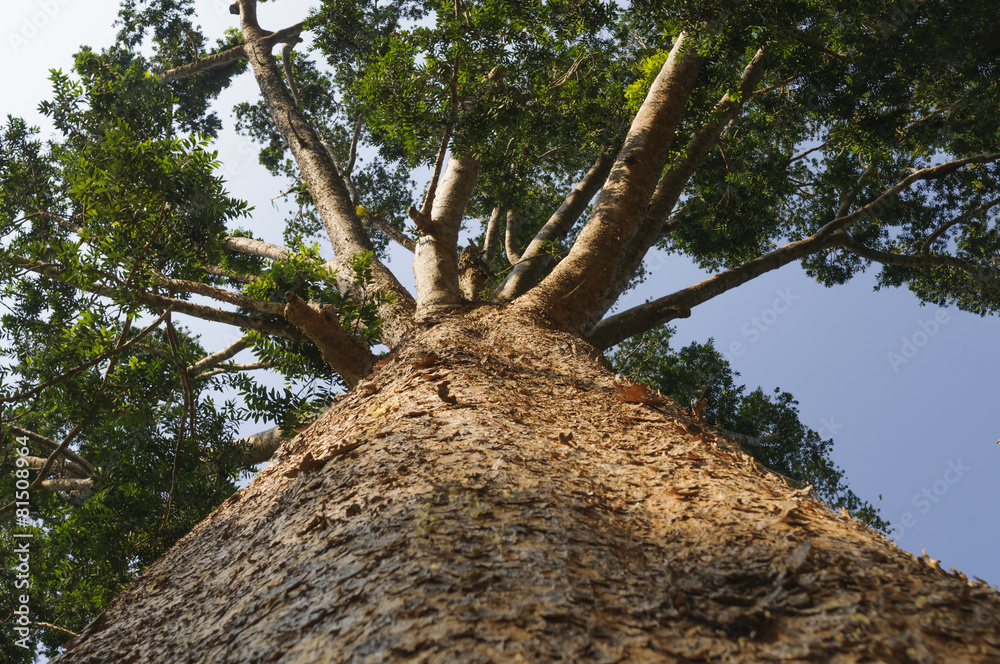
[285,291,375,388]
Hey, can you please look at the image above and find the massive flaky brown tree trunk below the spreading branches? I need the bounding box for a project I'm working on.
[53,306,1000,663]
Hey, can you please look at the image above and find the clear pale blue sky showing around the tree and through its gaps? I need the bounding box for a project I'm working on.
[0,0,1000,596]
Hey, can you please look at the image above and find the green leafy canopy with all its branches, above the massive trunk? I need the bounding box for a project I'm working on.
[0,0,1000,661]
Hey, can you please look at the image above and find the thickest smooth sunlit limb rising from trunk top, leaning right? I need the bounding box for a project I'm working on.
[512,33,701,332]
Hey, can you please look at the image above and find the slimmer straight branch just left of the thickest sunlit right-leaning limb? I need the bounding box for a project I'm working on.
[500,155,614,300]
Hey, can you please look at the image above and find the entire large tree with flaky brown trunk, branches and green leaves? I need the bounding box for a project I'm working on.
[0,0,1000,661]
